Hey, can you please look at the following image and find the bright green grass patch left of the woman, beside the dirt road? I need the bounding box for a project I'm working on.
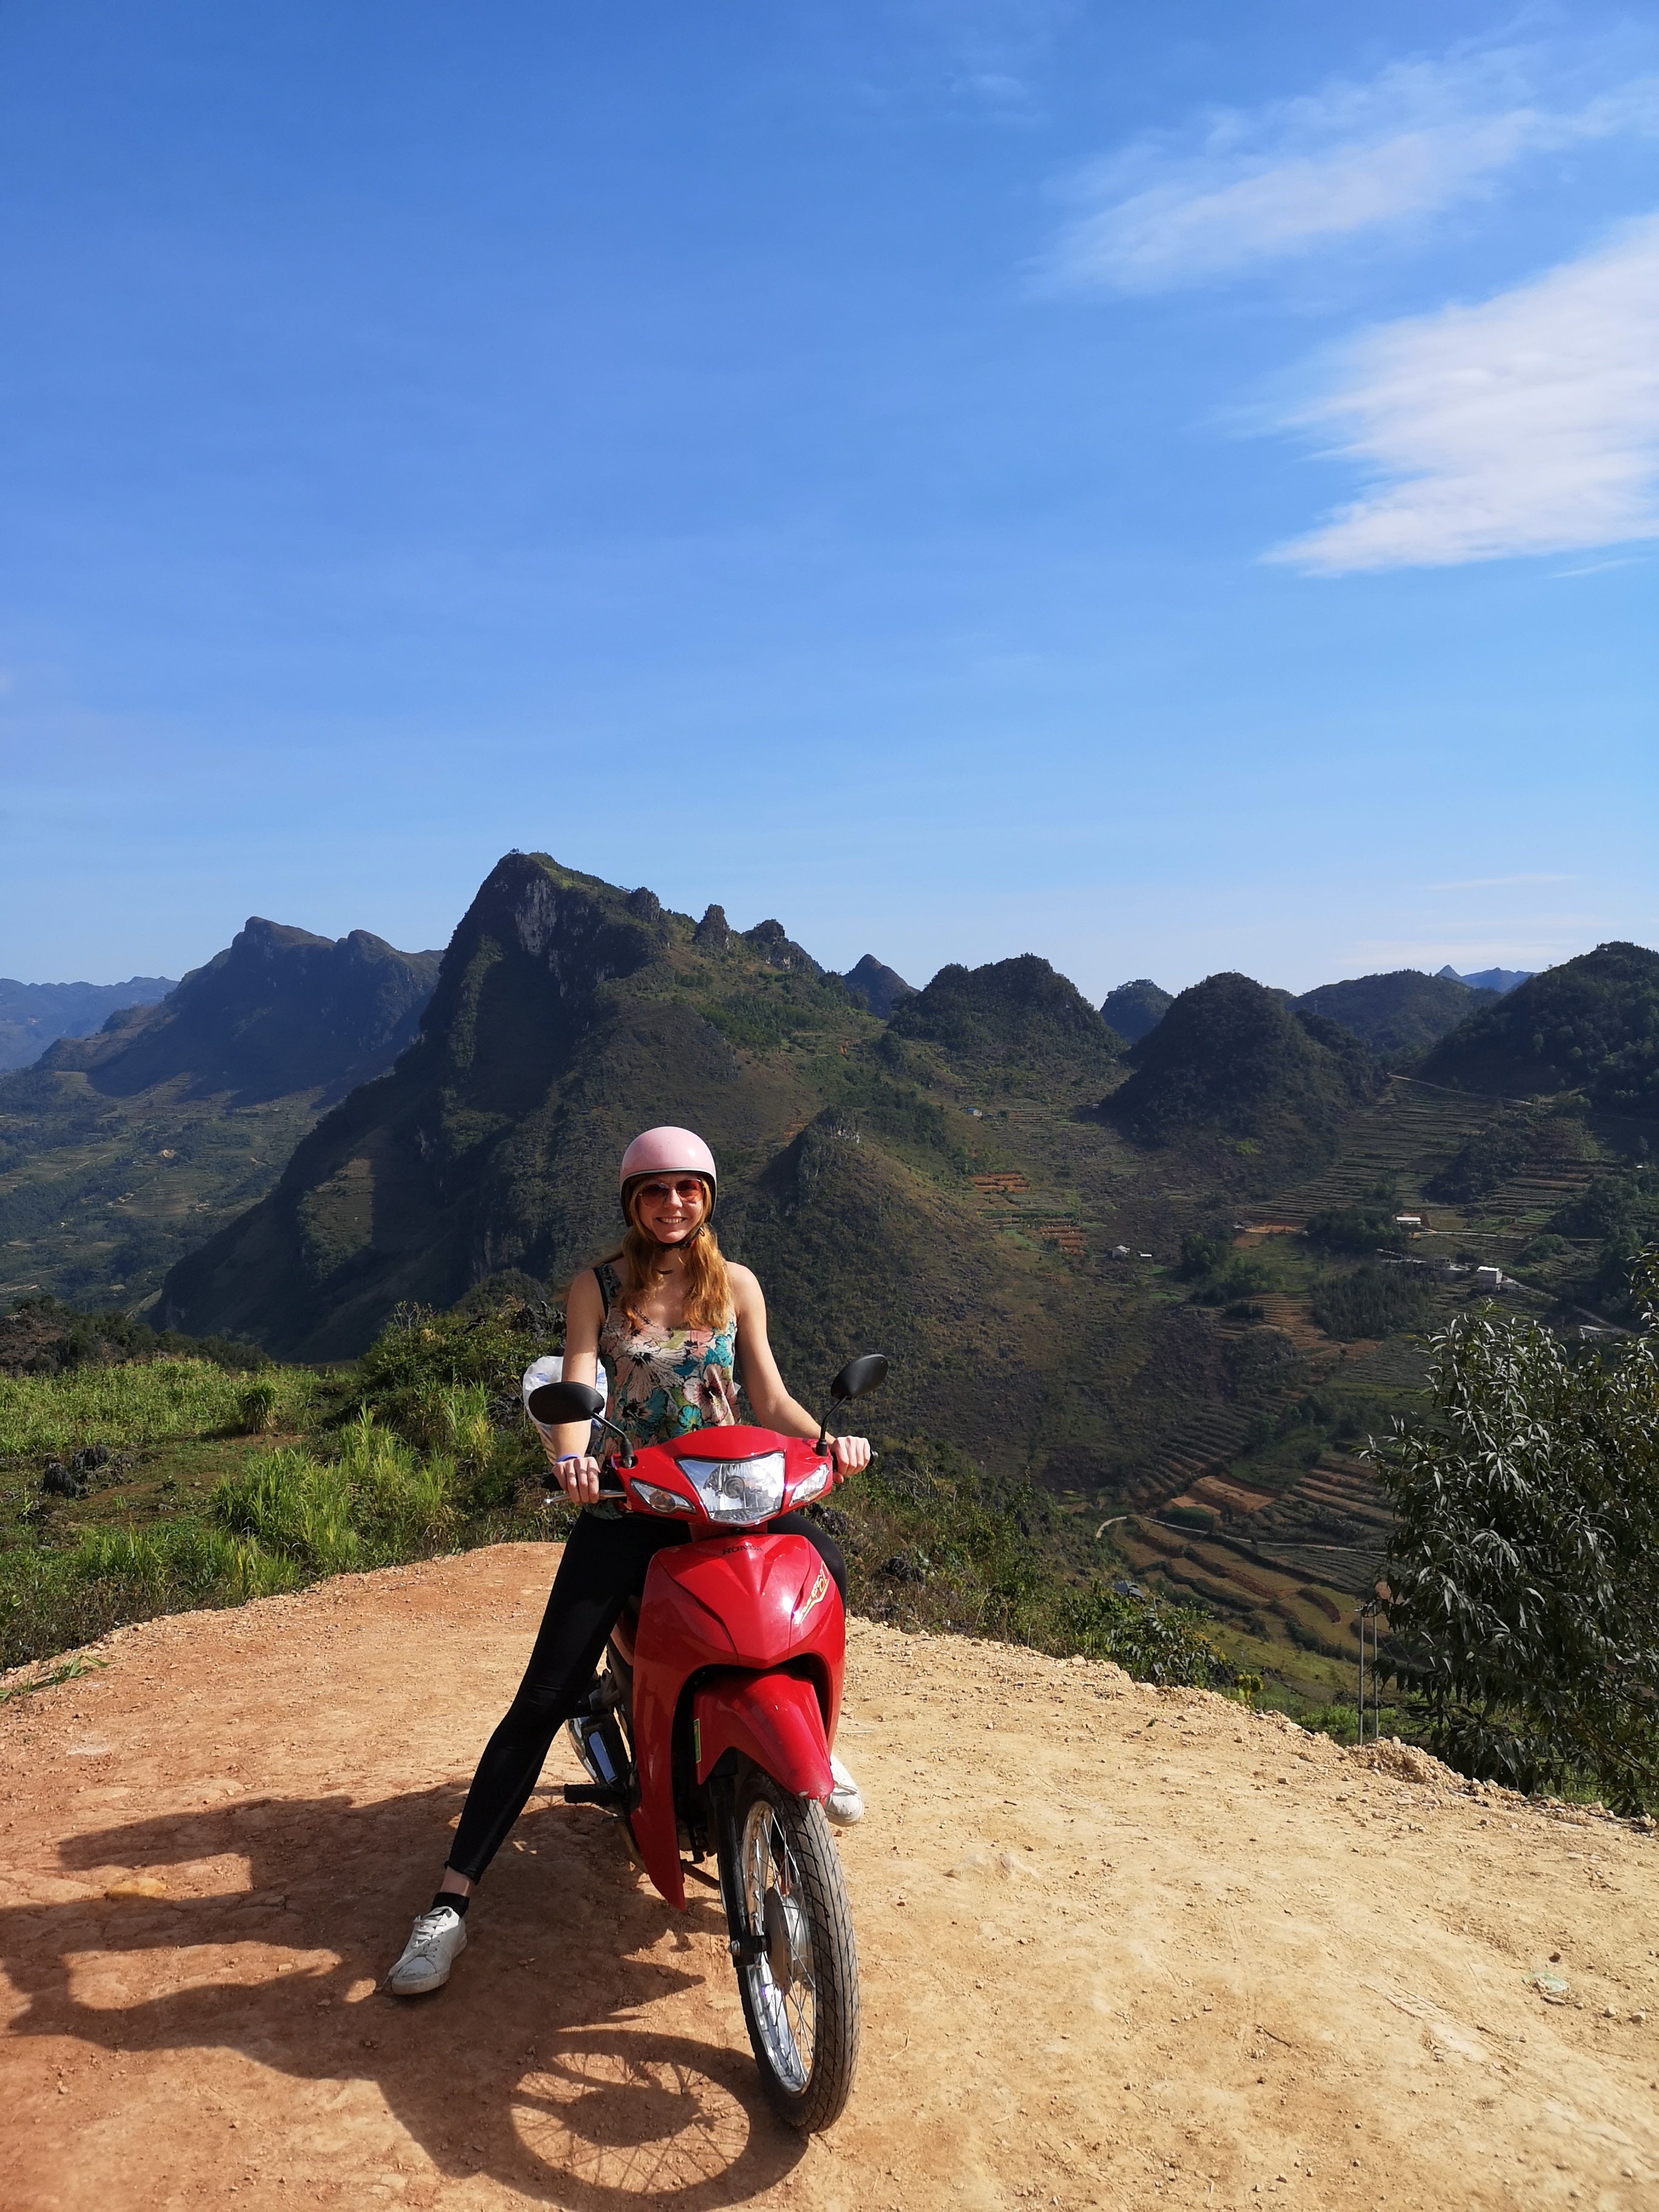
[0,1314,569,1668]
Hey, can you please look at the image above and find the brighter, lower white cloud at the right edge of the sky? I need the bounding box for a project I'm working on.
[1267,215,1659,575]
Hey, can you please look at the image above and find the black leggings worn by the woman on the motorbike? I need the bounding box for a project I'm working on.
[449,1513,847,1882]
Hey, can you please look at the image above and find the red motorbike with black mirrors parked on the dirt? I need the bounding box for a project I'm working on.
[526,1352,887,2130]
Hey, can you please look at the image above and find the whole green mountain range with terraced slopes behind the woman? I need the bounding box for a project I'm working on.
[13,854,1659,1681]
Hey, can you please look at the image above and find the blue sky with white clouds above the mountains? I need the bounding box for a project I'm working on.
[0,0,1659,997]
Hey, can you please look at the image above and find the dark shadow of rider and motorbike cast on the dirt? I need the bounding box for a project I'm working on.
[0,1789,805,2212]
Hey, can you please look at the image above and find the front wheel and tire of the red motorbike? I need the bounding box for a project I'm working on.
[728,1768,858,2134]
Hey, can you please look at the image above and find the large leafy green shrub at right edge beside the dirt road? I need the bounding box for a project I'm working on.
[1373,1252,1659,1812]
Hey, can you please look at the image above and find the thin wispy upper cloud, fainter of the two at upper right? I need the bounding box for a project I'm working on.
[1047,49,1659,292]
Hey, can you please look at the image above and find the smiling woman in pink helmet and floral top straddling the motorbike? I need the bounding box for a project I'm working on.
[387,1128,870,1997]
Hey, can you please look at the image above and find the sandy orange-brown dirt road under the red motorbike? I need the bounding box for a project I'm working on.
[0,1546,1659,2212]
